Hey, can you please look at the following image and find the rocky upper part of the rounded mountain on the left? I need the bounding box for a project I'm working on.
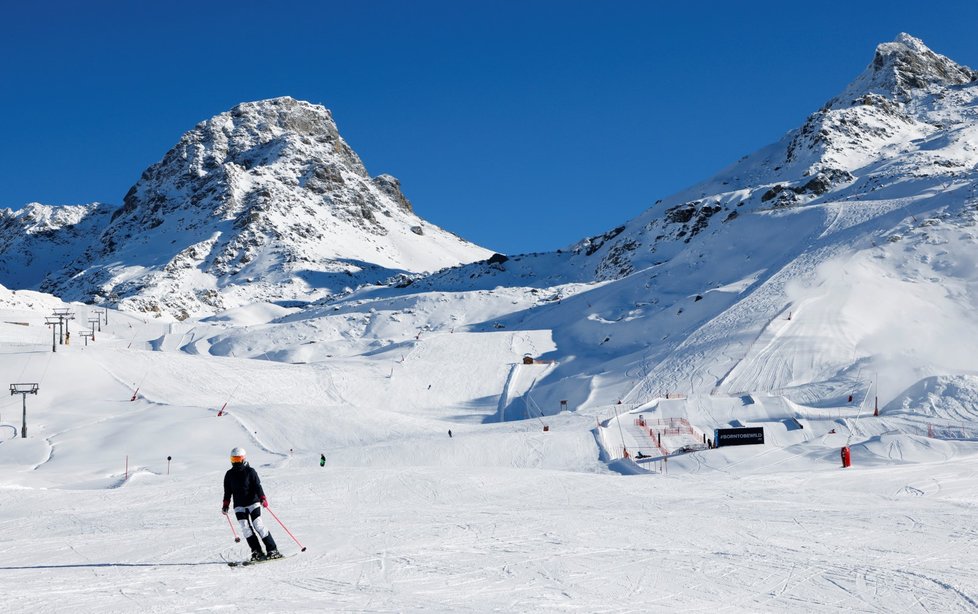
[104,97,424,254]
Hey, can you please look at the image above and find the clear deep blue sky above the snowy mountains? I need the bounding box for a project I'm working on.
[0,0,978,253]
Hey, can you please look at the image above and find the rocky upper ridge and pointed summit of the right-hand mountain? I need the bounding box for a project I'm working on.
[462,34,978,280]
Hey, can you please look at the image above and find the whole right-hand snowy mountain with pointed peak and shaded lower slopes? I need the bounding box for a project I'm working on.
[293,34,978,414]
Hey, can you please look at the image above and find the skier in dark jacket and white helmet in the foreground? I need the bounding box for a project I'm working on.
[221,448,282,561]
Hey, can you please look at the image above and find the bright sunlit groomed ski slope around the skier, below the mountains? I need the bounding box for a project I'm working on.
[0,235,978,612]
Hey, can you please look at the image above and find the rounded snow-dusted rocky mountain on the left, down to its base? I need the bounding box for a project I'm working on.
[0,97,491,319]
